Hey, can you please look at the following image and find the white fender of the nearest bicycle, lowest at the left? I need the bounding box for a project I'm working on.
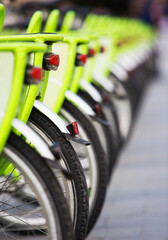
[12,118,55,160]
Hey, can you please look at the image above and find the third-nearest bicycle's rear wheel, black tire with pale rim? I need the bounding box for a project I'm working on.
[60,100,108,234]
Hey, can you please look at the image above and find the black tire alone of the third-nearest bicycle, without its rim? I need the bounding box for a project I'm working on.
[60,100,108,234]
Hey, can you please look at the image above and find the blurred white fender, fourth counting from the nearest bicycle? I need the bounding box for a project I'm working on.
[79,79,103,103]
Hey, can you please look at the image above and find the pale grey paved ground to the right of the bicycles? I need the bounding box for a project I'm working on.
[87,32,168,240]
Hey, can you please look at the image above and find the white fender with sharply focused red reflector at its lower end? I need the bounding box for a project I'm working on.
[34,100,70,134]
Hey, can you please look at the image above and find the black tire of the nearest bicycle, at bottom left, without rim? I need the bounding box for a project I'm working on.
[7,133,74,240]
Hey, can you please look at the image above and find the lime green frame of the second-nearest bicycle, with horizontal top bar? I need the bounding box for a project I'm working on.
[0,11,63,122]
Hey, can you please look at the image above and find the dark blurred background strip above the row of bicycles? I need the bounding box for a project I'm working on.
[1,0,168,26]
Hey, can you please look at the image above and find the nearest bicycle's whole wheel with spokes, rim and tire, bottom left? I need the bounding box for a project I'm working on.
[0,133,74,240]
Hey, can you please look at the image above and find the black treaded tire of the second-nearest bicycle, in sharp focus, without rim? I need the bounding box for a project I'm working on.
[29,108,89,240]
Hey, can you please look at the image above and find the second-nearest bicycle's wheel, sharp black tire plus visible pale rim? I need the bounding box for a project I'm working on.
[28,108,89,240]
